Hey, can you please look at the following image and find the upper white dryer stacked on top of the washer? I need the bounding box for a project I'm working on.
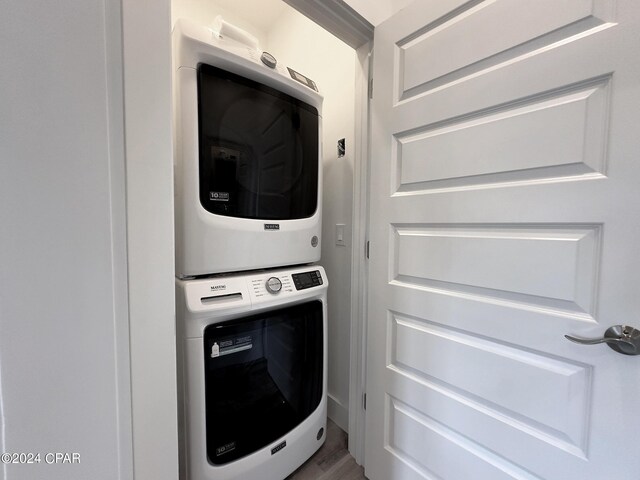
[173,20,322,278]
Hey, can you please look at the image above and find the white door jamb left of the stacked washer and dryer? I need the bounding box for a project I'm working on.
[121,0,178,480]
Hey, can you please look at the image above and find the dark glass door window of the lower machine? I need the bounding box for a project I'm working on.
[204,300,323,465]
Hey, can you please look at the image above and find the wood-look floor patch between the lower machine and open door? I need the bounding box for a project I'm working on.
[285,420,366,480]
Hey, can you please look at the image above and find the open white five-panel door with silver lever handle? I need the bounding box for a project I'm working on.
[365,0,640,480]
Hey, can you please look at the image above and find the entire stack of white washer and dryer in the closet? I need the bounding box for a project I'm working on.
[173,20,327,480]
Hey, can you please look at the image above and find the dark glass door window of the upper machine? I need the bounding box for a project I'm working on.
[198,64,318,220]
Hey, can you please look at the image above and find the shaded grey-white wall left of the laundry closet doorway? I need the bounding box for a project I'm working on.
[0,0,132,480]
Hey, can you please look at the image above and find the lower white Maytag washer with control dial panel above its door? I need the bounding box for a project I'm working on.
[176,265,327,480]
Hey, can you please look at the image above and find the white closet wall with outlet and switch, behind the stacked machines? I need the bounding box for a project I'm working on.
[267,9,356,431]
